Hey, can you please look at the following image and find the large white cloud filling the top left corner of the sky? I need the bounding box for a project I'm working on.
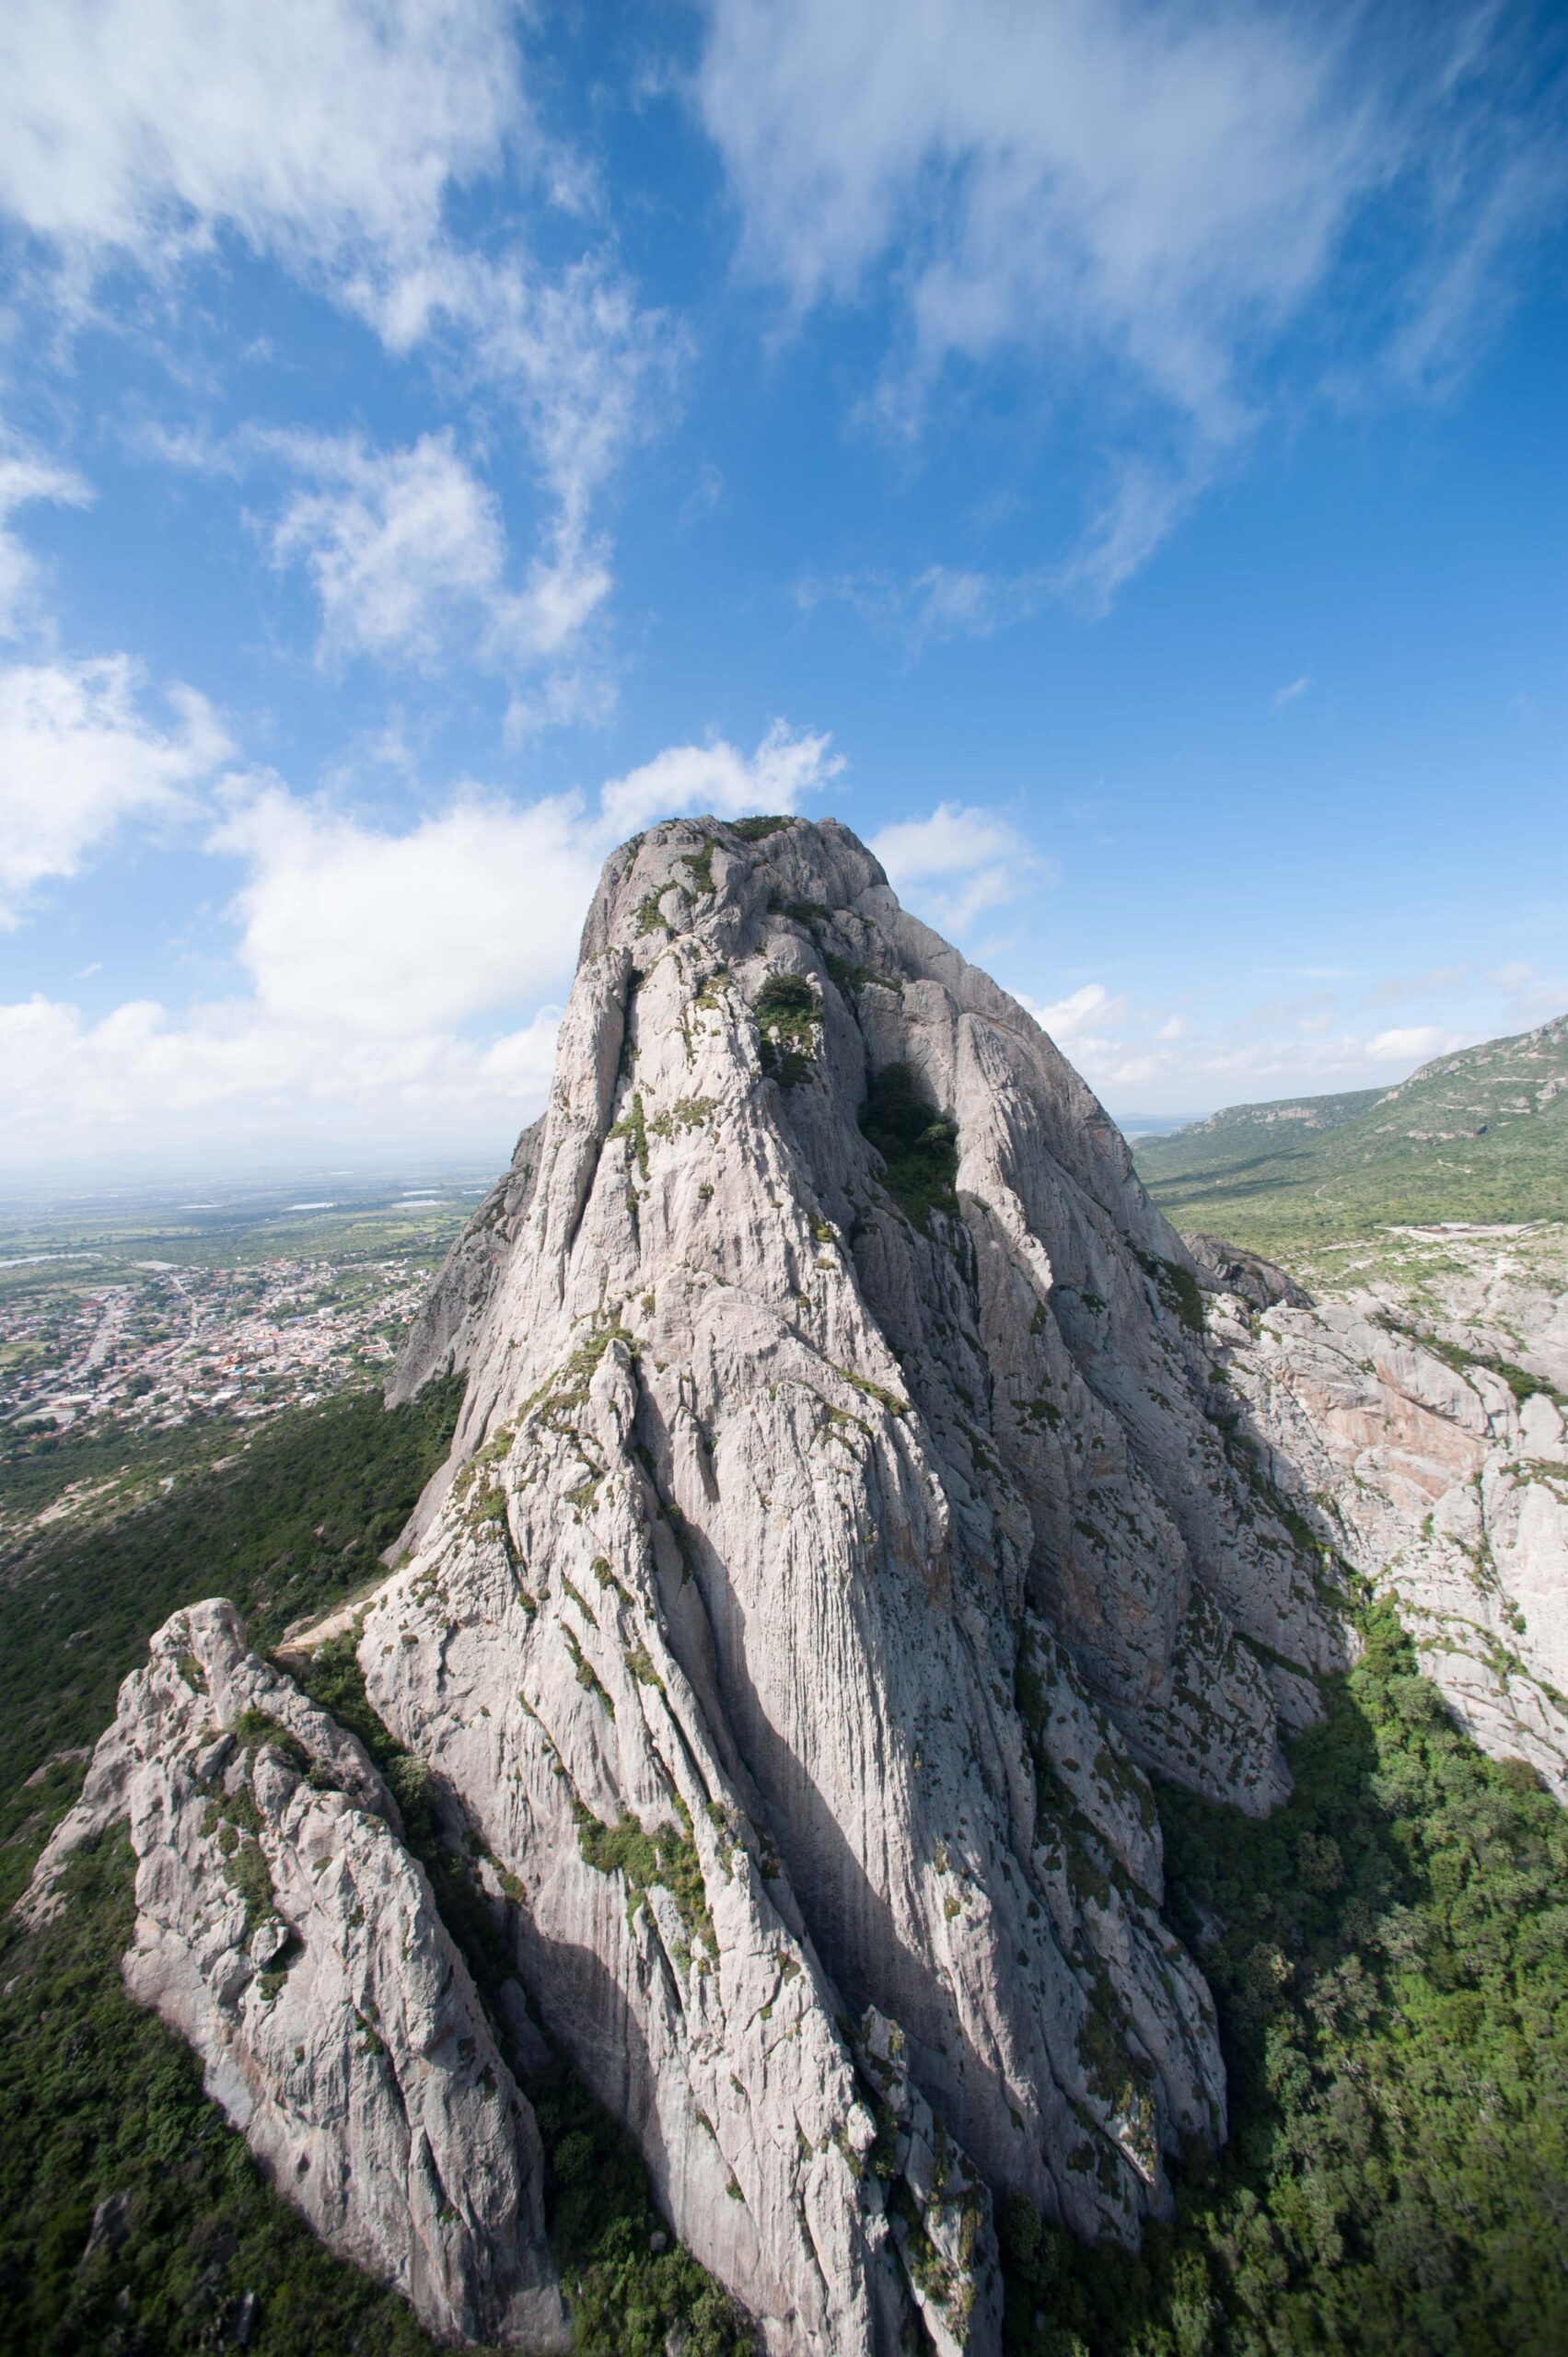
[0,0,526,287]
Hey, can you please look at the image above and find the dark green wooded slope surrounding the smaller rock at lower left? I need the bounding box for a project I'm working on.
[0,1386,736,2357]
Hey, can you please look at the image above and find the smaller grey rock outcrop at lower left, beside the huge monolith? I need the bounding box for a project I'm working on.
[29,1603,566,2350]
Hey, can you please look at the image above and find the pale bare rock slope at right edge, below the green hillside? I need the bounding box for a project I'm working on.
[1210,1228,1568,1801]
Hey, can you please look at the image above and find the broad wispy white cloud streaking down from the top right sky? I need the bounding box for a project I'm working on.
[695,0,1561,606]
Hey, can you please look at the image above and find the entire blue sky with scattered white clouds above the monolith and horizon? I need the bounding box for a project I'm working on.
[0,0,1568,1171]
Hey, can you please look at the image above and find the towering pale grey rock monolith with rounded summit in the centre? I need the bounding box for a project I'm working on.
[358,820,1337,2357]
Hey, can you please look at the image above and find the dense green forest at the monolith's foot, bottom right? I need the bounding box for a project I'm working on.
[1002,1605,1568,2357]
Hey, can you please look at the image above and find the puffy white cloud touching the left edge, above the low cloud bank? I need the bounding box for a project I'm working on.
[0,656,231,926]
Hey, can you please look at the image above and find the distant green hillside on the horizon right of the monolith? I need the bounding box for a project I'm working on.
[1134,1016,1568,1249]
